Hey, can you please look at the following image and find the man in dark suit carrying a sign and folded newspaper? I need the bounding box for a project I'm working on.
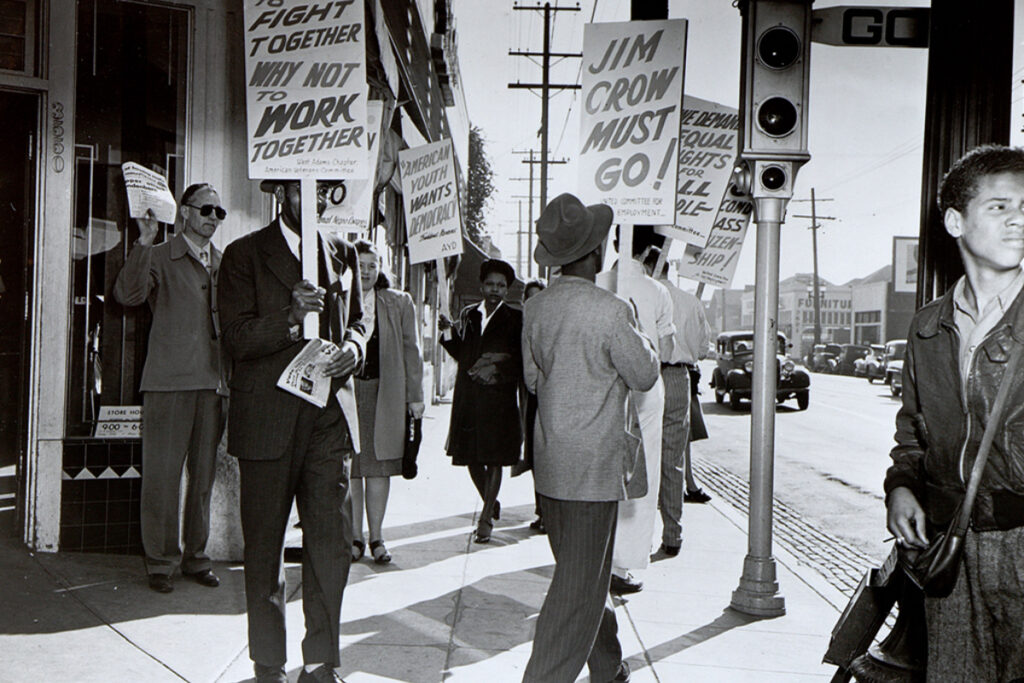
[218,180,366,683]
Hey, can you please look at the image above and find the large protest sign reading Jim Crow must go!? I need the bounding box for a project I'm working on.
[580,19,686,224]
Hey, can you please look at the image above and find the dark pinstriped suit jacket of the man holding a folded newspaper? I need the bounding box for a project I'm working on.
[217,220,366,460]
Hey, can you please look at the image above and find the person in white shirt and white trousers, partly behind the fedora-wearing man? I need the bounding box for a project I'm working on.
[597,231,676,595]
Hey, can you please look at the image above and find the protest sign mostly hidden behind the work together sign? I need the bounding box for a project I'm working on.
[318,99,384,232]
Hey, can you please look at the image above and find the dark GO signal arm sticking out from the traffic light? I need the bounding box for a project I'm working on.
[811,5,931,47]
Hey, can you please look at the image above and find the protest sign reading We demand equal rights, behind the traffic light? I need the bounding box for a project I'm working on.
[672,95,739,247]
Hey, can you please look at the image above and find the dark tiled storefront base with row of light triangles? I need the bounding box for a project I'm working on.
[60,439,142,554]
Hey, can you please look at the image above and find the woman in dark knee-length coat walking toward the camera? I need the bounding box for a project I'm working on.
[438,259,522,543]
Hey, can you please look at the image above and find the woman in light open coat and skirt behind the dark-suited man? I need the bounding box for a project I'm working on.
[351,240,424,564]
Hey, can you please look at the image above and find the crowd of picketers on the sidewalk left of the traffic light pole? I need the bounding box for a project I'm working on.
[114,180,710,682]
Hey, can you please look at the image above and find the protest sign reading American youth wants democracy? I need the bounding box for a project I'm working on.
[398,138,462,264]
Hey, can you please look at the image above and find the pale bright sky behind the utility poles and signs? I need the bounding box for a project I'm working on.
[453,0,928,296]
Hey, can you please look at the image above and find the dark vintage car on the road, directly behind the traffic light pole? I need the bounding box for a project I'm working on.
[711,331,811,411]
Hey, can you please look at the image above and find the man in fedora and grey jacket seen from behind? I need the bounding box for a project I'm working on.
[522,194,659,683]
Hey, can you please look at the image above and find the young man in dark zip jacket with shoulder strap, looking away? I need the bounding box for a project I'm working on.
[885,145,1024,682]
